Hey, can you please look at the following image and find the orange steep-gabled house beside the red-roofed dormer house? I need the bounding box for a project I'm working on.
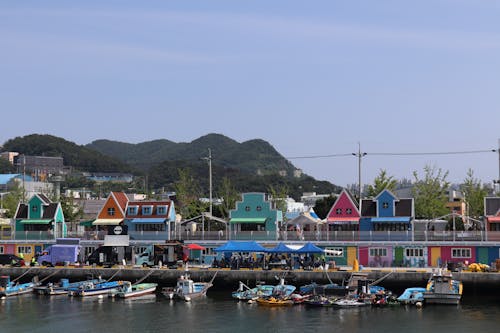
[92,192,129,234]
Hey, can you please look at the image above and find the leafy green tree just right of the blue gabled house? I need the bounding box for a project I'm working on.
[413,165,450,219]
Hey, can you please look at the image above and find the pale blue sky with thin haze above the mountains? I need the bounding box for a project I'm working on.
[0,0,500,186]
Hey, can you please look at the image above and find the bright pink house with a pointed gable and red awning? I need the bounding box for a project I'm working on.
[326,190,360,231]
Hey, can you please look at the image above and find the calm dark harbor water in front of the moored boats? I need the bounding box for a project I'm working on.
[0,291,500,333]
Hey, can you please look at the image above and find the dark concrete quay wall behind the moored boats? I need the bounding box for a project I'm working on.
[0,266,500,297]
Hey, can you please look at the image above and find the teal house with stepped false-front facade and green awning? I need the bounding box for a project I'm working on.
[229,193,283,239]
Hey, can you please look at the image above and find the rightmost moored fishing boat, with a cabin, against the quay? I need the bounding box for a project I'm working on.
[424,269,463,304]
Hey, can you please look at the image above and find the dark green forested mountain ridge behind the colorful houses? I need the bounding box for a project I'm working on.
[3,134,340,199]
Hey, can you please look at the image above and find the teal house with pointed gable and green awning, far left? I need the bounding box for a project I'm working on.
[14,194,67,239]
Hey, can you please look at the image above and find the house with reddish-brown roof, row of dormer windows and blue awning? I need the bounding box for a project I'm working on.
[124,200,175,240]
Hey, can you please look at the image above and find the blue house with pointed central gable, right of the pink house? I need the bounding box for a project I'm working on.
[359,189,415,240]
